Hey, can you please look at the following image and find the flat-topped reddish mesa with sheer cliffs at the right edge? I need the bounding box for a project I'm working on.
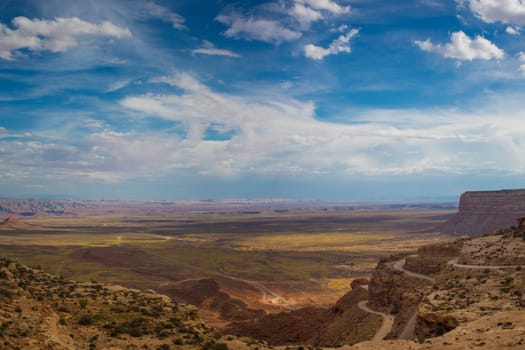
[434,189,525,236]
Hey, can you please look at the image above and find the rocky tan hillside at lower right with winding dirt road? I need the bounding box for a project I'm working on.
[342,228,525,350]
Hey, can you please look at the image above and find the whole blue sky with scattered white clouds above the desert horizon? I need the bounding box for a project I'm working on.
[0,0,525,200]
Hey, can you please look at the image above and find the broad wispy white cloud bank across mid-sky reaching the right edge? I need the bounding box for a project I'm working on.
[116,73,525,175]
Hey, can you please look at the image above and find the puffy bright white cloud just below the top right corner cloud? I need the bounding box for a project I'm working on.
[415,31,505,61]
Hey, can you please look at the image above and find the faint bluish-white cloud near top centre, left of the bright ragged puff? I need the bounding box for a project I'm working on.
[216,14,302,43]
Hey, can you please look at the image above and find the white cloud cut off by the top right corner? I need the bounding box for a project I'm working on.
[467,0,525,25]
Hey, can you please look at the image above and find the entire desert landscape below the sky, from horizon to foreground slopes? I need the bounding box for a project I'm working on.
[0,190,525,349]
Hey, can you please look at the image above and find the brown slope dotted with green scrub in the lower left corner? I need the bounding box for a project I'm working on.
[0,258,260,350]
